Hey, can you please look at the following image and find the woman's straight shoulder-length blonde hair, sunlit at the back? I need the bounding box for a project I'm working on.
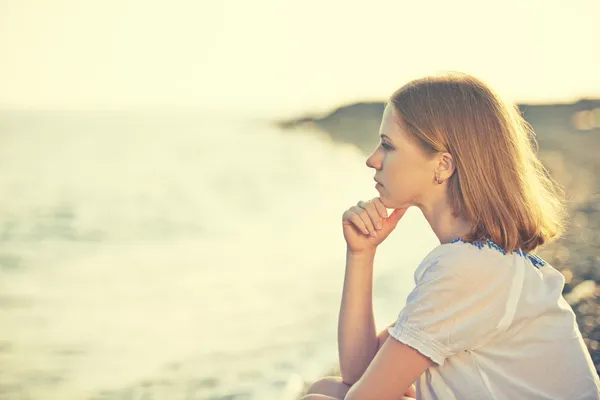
[389,72,567,252]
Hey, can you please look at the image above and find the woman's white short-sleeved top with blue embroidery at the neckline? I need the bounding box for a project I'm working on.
[388,238,600,400]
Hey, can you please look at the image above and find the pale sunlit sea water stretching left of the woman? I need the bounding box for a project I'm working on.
[0,111,439,400]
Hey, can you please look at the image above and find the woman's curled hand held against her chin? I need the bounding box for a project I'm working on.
[342,197,407,253]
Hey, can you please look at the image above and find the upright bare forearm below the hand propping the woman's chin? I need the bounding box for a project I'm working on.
[338,251,377,385]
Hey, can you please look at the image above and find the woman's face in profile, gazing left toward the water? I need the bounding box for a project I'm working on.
[366,104,436,208]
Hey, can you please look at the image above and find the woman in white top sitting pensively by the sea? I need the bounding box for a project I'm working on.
[303,73,600,400]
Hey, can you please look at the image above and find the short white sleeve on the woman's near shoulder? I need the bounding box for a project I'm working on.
[388,251,522,365]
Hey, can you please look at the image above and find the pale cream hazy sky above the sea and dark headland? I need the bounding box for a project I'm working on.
[0,0,600,117]
